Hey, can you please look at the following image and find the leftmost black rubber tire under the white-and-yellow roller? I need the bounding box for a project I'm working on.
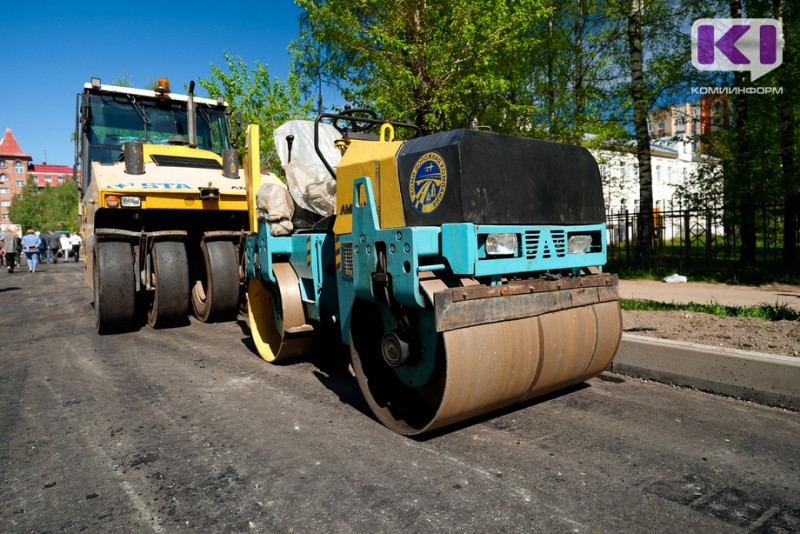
[92,241,138,334]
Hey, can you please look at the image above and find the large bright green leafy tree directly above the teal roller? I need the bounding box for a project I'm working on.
[292,0,547,132]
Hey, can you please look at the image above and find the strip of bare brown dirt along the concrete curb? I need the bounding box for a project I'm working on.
[622,310,800,357]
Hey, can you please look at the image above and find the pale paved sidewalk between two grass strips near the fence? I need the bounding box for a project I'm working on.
[619,280,800,311]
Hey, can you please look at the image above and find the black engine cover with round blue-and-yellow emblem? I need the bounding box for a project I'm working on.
[397,130,605,230]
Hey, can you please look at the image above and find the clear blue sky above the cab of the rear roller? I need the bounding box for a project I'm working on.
[0,0,310,166]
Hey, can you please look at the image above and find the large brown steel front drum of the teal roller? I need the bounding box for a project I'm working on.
[350,275,622,435]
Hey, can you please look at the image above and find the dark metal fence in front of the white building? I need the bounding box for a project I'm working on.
[606,205,800,268]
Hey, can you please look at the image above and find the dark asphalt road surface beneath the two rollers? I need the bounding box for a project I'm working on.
[0,263,800,533]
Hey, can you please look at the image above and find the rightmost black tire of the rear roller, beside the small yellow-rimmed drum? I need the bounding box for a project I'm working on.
[192,241,240,323]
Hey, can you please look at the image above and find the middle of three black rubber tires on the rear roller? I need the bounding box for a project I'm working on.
[147,241,189,328]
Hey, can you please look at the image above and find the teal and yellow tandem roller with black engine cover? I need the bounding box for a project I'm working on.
[245,110,622,435]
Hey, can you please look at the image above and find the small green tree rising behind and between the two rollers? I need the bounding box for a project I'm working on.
[198,52,313,171]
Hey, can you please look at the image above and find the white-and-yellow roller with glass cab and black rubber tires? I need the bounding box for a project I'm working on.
[75,78,255,333]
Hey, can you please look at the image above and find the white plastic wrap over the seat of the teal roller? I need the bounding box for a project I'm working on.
[272,121,342,217]
